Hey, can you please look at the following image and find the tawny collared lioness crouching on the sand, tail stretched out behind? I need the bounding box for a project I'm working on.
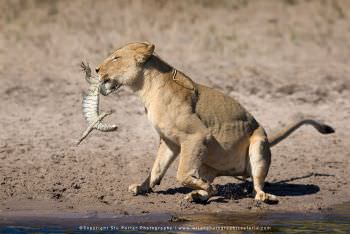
[96,42,334,202]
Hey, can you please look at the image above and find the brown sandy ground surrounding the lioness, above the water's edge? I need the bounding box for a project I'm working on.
[0,0,350,215]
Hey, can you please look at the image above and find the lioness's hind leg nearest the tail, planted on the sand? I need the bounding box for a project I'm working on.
[249,129,278,203]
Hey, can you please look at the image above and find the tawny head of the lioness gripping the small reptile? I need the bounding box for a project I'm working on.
[96,42,154,95]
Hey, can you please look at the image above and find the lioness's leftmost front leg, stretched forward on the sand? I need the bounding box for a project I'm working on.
[129,139,179,195]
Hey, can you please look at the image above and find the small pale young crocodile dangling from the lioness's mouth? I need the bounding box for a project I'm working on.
[77,63,118,145]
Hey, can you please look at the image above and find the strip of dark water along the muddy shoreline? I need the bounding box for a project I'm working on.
[0,203,350,233]
